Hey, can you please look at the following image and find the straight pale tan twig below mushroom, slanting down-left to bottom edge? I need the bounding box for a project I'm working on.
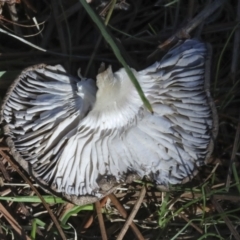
[117,186,146,240]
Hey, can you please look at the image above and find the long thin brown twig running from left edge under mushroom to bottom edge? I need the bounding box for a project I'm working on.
[0,149,67,240]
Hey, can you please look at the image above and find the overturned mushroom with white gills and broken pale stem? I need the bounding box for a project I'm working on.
[1,39,217,205]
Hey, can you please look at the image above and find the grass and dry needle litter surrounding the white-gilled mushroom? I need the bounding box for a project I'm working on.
[0,0,240,240]
